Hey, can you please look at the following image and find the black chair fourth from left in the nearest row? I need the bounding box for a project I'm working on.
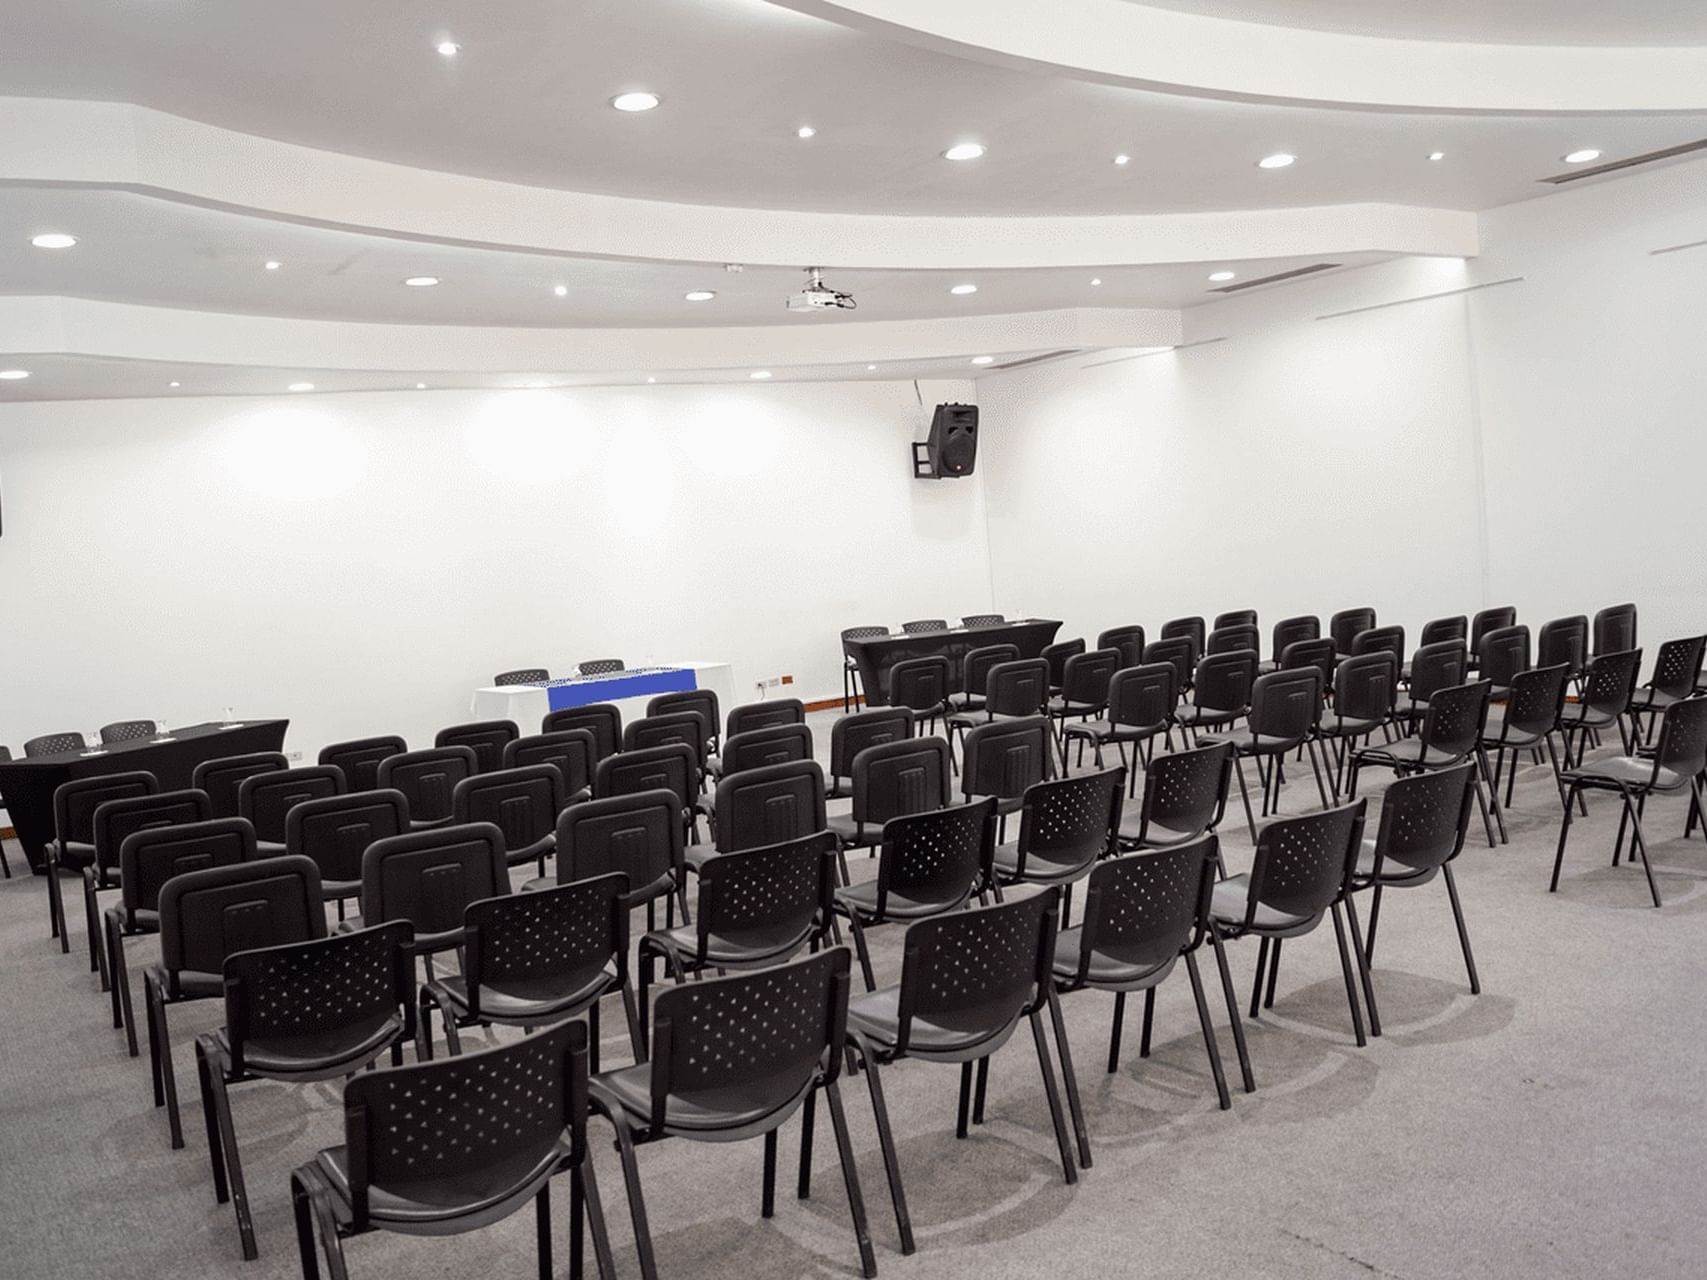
[1053,836,1256,1111]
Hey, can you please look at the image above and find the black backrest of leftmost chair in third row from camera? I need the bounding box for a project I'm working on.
[160,857,326,995]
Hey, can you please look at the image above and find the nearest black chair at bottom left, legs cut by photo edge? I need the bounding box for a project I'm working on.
[290,1022,615,1280]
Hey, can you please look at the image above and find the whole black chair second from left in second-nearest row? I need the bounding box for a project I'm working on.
[420,872,645,1067]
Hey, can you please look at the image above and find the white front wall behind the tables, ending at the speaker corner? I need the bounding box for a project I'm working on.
[0,382,990,758]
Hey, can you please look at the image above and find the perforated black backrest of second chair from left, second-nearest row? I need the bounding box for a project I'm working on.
[463,872,628,1019]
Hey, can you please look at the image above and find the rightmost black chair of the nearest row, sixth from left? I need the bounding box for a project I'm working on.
[1352,761,1482,995]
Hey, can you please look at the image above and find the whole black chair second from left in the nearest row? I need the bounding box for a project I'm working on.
[587,947,877,1280]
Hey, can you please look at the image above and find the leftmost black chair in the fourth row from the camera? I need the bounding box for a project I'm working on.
[102,817,254,1058]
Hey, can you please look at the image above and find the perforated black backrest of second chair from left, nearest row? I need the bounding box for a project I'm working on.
[650,947,852,1133]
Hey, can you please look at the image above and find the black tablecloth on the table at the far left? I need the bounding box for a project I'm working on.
[0,720,290,872]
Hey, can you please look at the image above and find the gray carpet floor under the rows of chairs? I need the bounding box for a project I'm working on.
[0,715,1707,1280]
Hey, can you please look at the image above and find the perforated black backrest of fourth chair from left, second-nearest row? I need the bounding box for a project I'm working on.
[877,797,995,918]
